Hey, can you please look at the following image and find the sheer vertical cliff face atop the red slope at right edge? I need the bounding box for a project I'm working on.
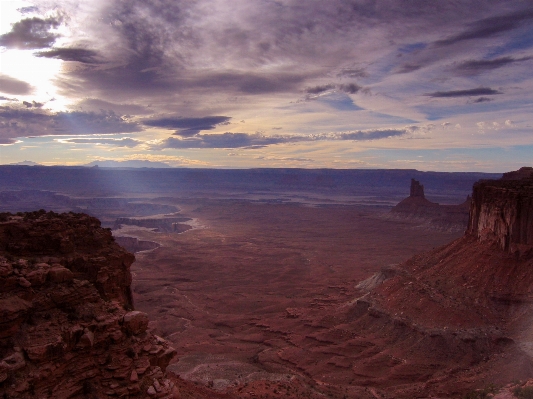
[468,177,533,252]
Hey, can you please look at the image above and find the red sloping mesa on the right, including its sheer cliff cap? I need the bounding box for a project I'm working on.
[347,170,533,398]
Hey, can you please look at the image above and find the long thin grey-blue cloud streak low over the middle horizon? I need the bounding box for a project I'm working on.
[152,129,408,150]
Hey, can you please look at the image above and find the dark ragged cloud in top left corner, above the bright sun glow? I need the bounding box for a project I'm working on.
[0,17,61,50]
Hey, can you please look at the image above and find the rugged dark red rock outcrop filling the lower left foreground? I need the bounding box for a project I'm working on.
[0,211,176,398]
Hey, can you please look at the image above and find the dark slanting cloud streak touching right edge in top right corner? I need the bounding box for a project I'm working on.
[435,9,533,46]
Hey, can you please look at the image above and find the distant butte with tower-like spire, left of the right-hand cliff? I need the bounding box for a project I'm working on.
[390,179,470,232]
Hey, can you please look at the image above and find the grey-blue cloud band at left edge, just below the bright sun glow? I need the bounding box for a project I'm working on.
[0,106,142,144]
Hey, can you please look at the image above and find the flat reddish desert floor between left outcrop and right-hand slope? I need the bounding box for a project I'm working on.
[128,199,462,397]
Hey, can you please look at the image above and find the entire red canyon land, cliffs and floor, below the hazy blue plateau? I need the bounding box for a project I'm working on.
[0,168,533,399]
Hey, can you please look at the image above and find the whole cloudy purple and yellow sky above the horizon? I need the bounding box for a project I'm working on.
[0,0,533,172]
